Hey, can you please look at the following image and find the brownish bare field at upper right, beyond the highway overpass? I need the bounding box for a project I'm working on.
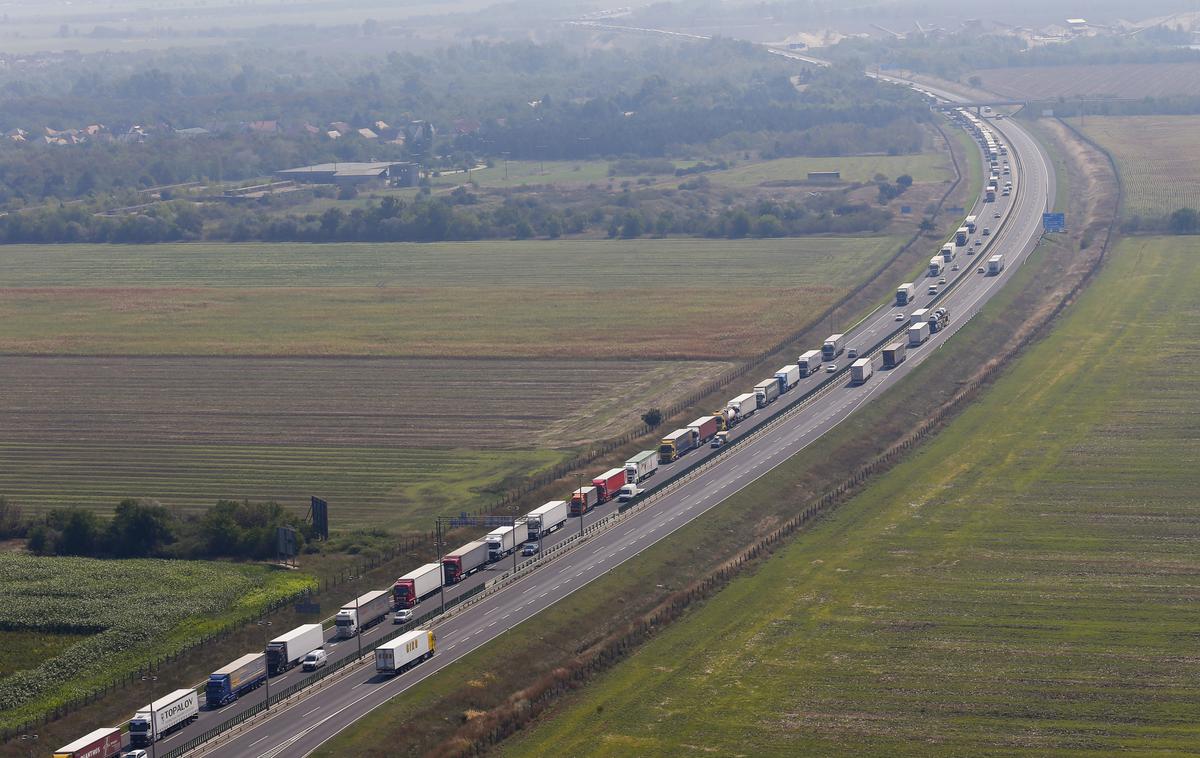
[972,64,1200,100]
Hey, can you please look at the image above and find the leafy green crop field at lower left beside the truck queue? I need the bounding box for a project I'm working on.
[0,552,311,728]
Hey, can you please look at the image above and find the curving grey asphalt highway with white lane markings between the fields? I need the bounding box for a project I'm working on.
[146,88,1054,758]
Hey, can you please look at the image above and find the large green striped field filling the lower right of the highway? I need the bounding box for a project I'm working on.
[504,239,1200,756]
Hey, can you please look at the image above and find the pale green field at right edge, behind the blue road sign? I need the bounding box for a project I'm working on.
[1084,115,1200,218]
